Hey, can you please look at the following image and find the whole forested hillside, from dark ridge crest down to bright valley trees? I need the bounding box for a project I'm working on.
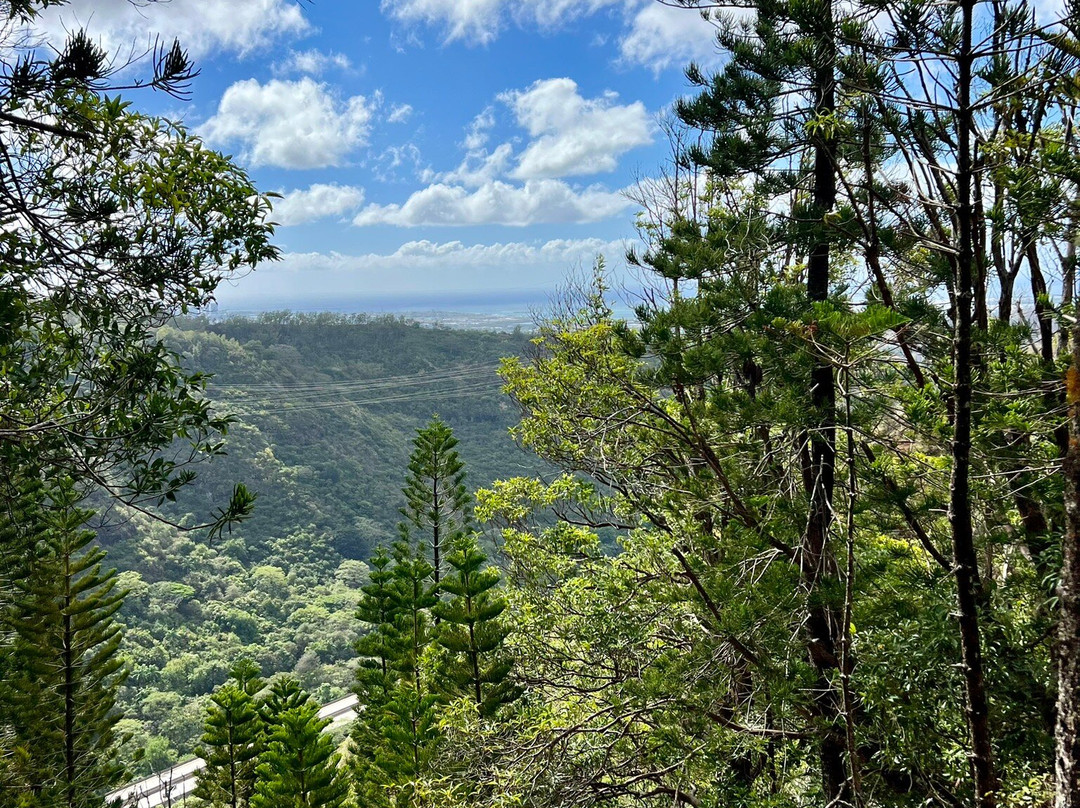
[99,313,540,770]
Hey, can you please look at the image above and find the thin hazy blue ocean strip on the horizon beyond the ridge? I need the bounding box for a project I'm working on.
[214,289,633,331]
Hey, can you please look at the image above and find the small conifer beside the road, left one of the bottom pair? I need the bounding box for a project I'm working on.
[193,659,264,808]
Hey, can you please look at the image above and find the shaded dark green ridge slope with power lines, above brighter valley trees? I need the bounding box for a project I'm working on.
[150,312,536,558]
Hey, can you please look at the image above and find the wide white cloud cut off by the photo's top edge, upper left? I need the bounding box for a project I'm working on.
[40,0,311,58]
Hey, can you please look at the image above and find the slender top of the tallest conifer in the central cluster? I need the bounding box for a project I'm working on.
[400,416,470,585]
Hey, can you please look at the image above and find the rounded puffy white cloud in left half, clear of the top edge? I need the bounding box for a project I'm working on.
[199,77,372,169]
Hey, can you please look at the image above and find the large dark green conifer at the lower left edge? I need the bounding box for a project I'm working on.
[0,480,126,808]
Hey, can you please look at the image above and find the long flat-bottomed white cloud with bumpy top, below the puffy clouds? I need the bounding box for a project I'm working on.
[353,179,631,227]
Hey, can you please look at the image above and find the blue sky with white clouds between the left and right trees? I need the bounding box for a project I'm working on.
[39,0,716,308]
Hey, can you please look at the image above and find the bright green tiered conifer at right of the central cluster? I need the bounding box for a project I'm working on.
[432,535,519,717]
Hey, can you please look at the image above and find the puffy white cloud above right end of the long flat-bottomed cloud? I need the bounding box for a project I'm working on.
[501,79,653,179]
